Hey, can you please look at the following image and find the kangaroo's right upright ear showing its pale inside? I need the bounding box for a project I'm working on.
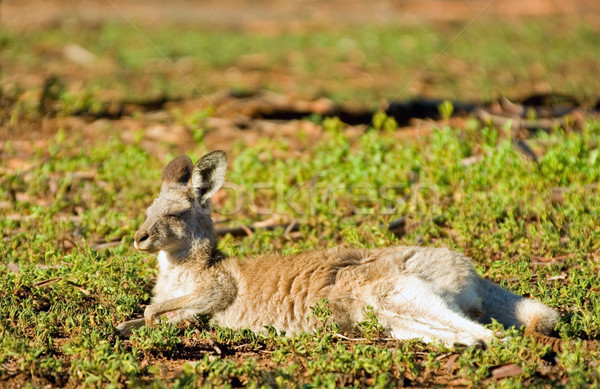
[191,150,227,203]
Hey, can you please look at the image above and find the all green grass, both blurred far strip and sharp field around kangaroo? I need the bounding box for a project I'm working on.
[0,12,600,388]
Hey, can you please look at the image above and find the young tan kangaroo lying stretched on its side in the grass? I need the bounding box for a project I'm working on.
[117,151,558,346]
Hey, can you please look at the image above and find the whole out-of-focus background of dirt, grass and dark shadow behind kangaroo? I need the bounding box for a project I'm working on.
[0,0,600,151]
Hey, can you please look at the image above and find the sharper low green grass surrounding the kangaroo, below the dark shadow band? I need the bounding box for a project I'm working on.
[0,113,600,387]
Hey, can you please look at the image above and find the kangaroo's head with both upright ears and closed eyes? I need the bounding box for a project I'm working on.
[134,150,227,258]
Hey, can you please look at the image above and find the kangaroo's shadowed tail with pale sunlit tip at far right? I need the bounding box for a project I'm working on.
[479,278,559,334]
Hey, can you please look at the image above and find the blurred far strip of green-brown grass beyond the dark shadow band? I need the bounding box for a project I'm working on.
[0,18,600,107]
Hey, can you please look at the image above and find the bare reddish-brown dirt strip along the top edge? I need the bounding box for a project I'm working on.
[0,0,600,31]
